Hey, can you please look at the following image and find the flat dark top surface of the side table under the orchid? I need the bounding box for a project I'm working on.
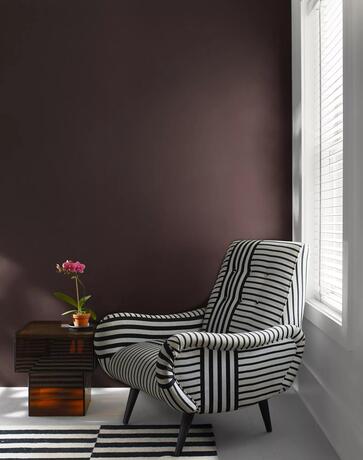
[16,321,96,338]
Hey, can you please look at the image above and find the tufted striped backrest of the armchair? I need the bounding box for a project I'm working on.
[203,240,308,332]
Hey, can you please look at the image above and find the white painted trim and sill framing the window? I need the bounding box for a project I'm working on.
[291,0,356,350]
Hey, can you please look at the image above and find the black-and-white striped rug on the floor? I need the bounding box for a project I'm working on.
[0,425,217,460]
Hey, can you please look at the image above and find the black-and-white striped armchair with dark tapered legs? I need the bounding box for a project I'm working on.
[95,240,308,456]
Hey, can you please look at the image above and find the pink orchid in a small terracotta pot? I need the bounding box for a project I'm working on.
[54,260,96,327]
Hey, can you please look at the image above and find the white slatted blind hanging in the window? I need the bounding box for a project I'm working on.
[313,0,343,311]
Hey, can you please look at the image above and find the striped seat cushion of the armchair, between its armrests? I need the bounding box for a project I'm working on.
[107,340,164,399]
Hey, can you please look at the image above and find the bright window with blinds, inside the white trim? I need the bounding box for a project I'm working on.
[303,0,343,316]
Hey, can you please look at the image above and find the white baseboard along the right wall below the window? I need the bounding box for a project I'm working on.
[294,363,363,460]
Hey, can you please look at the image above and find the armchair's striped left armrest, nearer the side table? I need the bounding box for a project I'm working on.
[94,308,205,364]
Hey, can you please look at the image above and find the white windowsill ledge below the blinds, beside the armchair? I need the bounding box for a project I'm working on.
[305,299,351,350]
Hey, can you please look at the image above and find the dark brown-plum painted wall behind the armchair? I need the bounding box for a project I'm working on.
[0,0,291,385]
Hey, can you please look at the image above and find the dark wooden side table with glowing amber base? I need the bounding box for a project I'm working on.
[15,321,96,416]
